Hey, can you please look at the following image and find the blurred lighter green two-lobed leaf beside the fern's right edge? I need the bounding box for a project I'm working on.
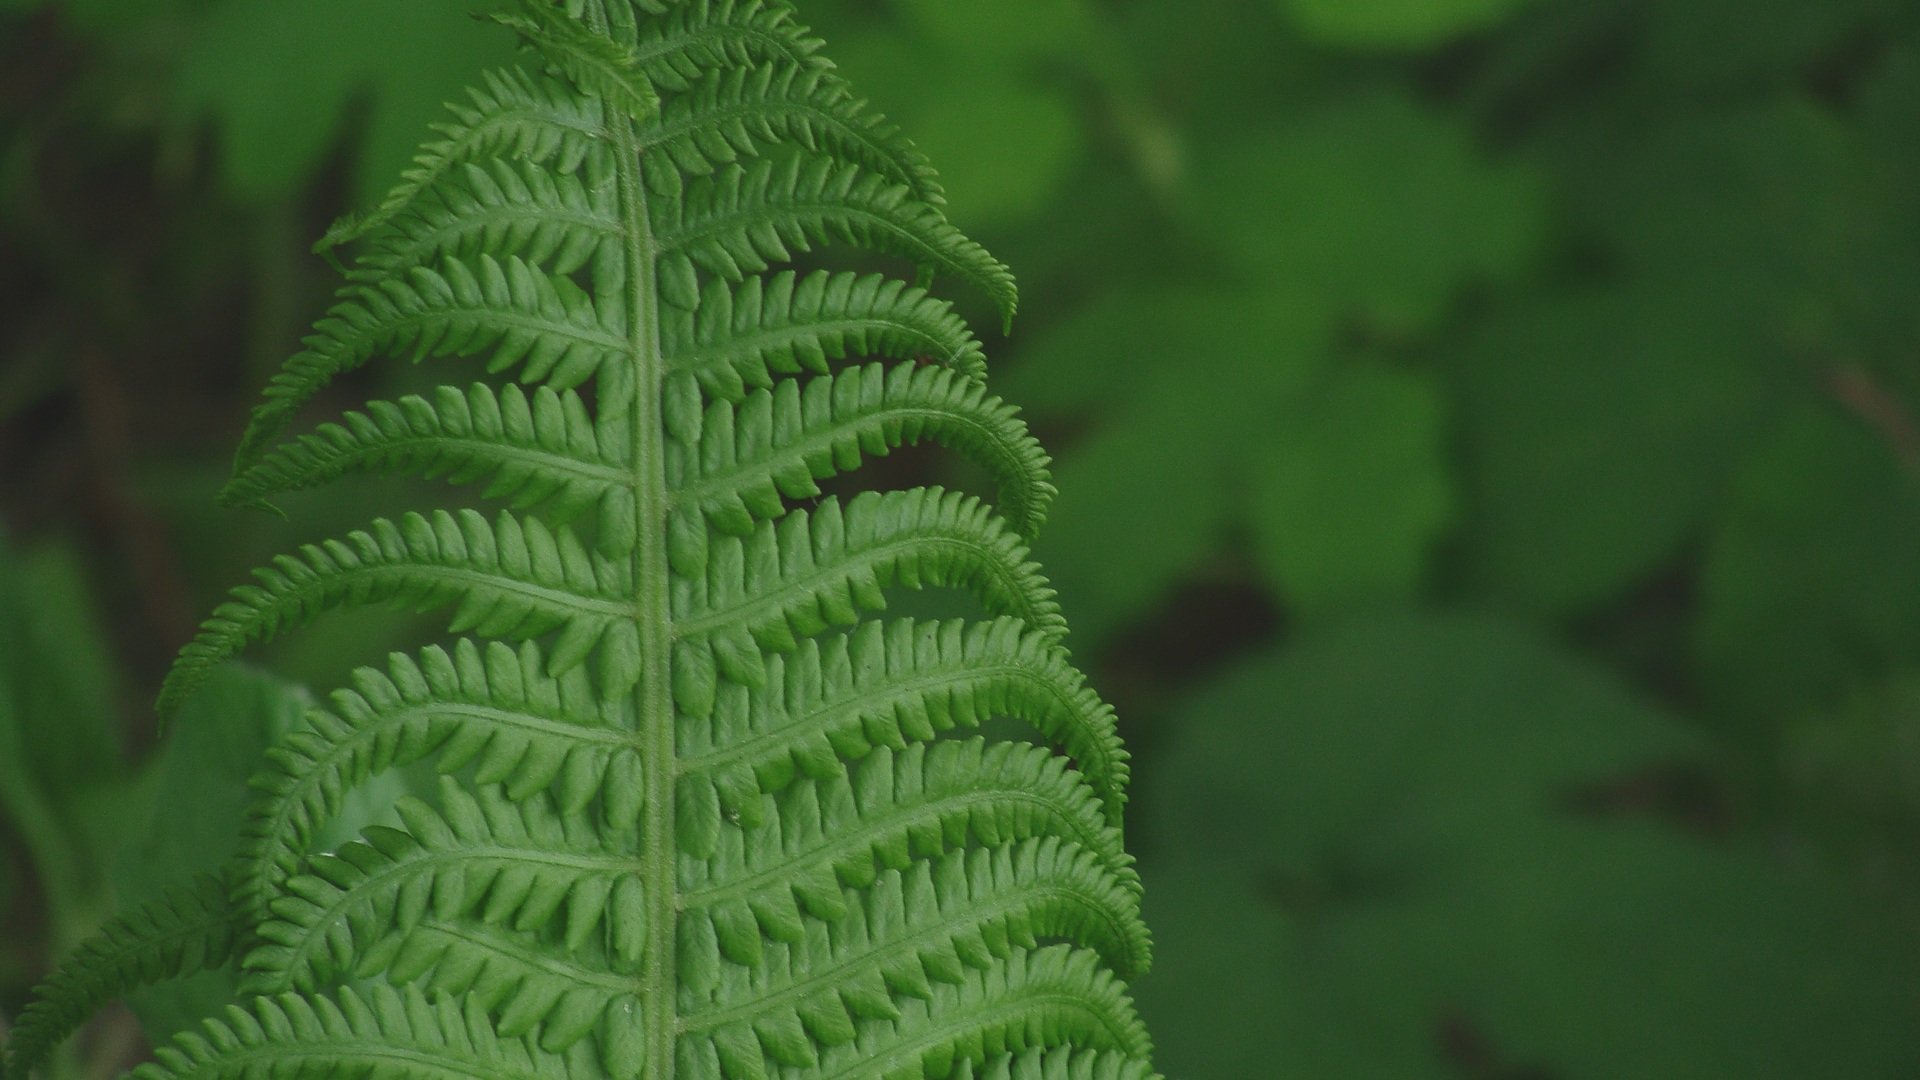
[1010,288,1452,646]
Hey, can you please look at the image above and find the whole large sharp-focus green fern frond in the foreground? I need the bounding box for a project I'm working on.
[8,0,1152,1080]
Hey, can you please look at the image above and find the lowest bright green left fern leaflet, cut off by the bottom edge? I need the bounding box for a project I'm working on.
[131,984,597,1080]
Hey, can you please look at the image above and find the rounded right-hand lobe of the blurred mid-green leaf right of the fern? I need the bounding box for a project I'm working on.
[1248,367,1453,609]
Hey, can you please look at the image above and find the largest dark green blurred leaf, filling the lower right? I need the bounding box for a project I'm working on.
[1140,615,1920,1080]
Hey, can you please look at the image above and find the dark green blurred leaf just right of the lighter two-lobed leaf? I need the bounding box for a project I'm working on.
[1457,288,1784,615]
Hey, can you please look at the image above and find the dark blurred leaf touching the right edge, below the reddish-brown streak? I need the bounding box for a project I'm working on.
[1697,395,1920,723]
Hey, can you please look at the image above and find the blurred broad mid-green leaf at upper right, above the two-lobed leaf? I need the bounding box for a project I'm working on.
[1188,92,1544,334]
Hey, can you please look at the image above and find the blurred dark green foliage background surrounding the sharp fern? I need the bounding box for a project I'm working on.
[0,0,1920,1080]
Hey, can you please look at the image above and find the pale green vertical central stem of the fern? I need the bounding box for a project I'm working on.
[593,12,680,1080]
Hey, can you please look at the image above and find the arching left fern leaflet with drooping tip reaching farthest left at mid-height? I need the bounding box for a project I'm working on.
[159,509,636,715]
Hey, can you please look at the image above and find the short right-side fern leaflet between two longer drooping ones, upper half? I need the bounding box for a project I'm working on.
[660,271,987,398]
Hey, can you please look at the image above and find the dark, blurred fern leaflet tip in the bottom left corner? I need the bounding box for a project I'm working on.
[0,874,240,1080]
